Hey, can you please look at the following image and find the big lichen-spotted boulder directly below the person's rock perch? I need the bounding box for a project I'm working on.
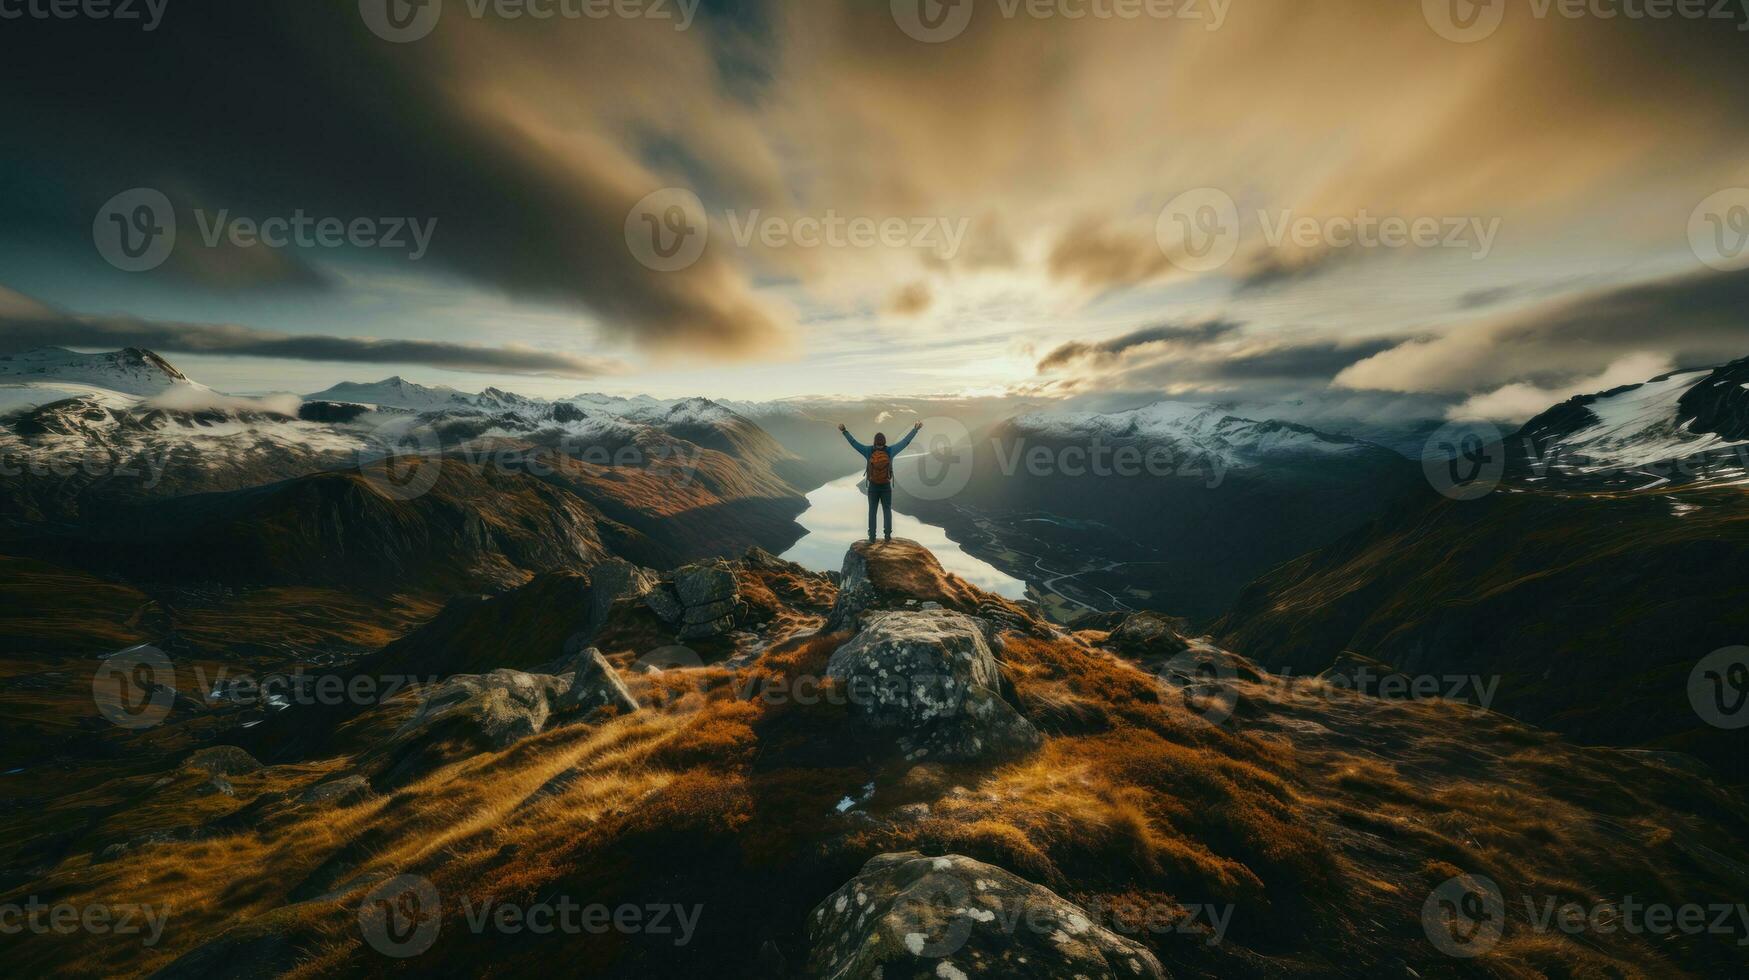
[826,609,1041,760]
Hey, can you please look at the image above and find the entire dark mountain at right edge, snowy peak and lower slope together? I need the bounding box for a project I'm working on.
[1214,361,1749,781]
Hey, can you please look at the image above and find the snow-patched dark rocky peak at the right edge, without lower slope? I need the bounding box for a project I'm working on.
[1509,357,1749,488]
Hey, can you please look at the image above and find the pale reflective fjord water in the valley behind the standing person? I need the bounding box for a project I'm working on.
[782,471,1027,599]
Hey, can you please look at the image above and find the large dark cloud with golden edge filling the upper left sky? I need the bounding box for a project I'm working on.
[0,2,785,355]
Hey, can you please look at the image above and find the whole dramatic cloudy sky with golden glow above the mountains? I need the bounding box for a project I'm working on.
[0,0,1749,418]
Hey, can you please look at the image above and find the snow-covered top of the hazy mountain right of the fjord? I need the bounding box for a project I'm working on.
[1007,401,1387,467]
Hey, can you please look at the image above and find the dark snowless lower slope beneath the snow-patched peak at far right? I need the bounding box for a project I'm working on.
[1214,487,1749,781]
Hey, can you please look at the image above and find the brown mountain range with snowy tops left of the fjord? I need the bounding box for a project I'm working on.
[0,348,805,616]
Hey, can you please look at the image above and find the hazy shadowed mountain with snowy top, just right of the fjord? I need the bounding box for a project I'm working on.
[897,403,1420,620]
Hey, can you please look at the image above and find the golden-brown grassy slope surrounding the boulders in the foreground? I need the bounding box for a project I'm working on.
[0,556,1749,977]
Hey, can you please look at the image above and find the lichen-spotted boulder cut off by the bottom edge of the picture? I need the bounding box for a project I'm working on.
[808,851,1170,980]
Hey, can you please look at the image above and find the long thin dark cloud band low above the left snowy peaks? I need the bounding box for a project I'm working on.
[0,310,623,378]
